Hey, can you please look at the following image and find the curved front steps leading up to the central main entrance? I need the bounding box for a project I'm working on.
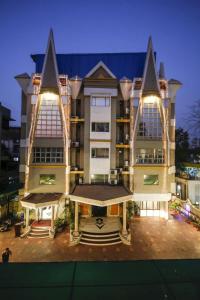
[80,231,122,246]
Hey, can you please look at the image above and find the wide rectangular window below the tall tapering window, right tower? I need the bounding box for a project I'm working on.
[136,149,164,164]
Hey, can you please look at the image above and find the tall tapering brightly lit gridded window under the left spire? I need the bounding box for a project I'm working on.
[35,97,62,137]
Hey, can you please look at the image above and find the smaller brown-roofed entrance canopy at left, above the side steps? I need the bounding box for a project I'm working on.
[21,193,63,209]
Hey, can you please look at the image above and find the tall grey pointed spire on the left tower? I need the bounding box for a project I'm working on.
[41,29,59,92]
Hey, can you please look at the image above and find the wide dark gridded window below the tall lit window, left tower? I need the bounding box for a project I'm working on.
[33,147,63,163]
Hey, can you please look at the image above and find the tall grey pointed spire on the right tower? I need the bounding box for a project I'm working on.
[142,37,160,96]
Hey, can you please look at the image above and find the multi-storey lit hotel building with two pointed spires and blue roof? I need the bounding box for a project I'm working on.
[16,32,181,245]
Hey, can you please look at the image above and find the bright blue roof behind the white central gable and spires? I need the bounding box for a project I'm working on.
[31,52,146,79]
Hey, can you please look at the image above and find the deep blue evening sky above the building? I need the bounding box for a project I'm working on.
[0,0,200,126]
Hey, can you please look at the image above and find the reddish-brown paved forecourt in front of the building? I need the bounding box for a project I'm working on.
[0,216,200,262]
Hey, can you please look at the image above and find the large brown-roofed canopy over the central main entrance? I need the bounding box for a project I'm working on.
[69,184,132,206]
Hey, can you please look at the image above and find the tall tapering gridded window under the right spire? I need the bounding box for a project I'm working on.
[137,102,162,139]
